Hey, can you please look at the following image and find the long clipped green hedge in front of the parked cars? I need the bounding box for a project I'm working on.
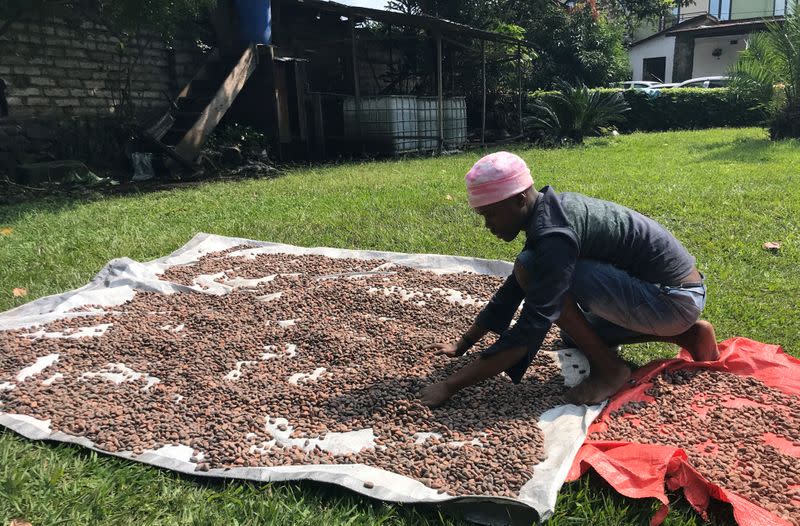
[528,88,765,132]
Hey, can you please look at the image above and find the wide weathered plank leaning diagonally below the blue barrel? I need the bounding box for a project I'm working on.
[175,46,258,161]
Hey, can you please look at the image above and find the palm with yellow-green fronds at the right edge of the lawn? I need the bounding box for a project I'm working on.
[730,0,800,140]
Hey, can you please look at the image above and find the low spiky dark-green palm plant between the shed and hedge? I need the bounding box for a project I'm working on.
[525,81,630,144]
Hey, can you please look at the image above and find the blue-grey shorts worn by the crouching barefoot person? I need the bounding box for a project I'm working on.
[565,259,707,344]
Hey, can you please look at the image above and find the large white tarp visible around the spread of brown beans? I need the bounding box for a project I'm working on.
[0,234,602,524]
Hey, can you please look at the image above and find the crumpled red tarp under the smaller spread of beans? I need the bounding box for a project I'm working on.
[567,338,800,526]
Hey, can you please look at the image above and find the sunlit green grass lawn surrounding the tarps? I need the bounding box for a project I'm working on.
[0,129,800,526]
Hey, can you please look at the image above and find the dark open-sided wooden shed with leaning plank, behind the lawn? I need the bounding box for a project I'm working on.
[149,0,528,163]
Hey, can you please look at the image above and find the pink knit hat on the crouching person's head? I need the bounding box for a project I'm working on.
[466,152,533,208]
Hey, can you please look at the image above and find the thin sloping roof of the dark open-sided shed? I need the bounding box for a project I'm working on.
[273,0,533,47]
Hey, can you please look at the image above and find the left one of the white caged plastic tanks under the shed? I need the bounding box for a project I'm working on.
[343,95,419,153]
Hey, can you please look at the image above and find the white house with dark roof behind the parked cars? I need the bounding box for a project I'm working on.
[628,0,791,82]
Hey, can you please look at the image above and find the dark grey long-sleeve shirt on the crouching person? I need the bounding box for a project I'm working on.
[476,186,695,383]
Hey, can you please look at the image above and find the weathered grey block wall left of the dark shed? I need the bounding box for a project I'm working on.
[0,19,203,171]
